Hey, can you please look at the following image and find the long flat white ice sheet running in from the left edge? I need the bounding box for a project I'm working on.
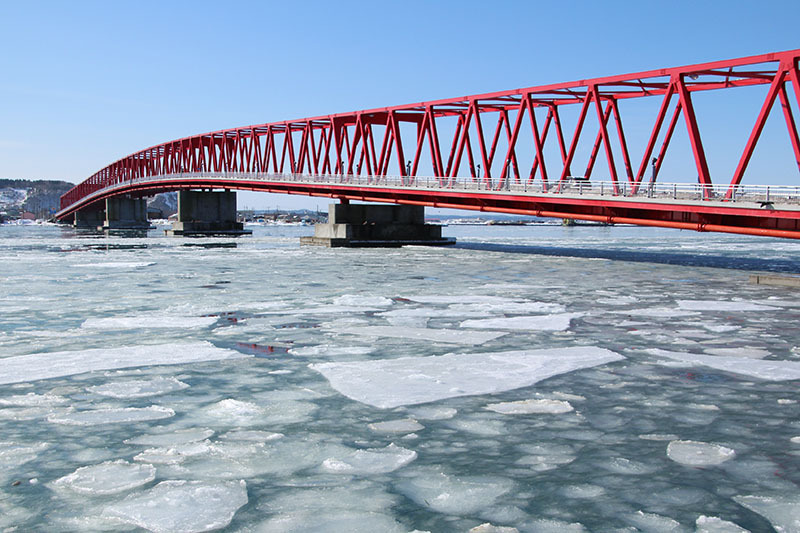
[0,342,252,385]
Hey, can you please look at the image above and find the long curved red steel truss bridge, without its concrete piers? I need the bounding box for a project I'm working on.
[56,50,800,238]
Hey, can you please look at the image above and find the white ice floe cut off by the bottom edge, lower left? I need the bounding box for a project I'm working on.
[104,481,248,533]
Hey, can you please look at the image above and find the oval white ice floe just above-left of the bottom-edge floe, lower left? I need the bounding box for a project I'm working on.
[53,460,156,495]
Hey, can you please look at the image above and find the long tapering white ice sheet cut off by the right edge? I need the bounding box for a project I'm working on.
[647,348,800,381]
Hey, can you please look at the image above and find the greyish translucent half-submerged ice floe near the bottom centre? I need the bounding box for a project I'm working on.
[397,469,514,516]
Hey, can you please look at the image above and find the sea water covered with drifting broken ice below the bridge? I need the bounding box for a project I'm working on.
[0,221,800,533]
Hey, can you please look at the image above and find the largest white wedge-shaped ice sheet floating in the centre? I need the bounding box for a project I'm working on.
[310,346,624,408]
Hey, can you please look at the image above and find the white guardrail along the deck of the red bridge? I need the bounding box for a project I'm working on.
[67,172,800,208]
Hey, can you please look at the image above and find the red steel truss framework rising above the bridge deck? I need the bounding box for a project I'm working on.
[61,50,800,210]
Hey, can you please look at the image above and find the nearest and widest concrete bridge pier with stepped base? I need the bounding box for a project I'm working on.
[300,204,456,248]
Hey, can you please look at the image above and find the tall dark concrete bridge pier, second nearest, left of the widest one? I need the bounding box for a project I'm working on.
[166,191,253,236]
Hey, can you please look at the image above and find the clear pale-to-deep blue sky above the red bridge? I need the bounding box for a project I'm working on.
[0,0,800,208]
